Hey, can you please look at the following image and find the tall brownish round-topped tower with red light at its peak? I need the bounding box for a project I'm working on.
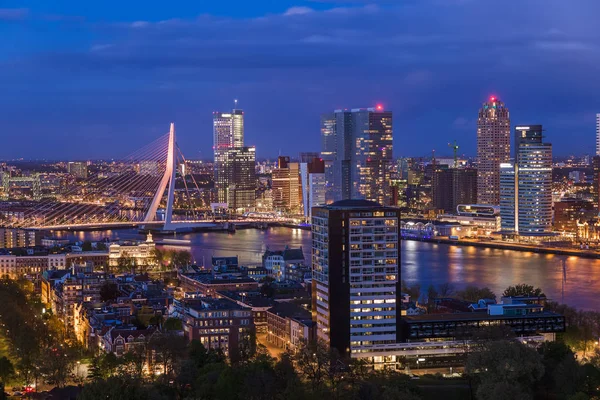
[477,97,510,205]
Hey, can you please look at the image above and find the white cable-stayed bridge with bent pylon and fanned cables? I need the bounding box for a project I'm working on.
[3,123,292,231]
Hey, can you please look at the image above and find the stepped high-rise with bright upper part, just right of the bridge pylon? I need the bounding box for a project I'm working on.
[213,109,256,211]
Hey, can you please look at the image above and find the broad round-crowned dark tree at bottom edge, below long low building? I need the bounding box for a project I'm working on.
[465,340,544,400]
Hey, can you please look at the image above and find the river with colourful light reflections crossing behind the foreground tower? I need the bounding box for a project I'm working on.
[54,228,600,310]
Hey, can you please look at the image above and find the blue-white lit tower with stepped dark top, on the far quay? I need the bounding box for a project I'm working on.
[500,125,552,236]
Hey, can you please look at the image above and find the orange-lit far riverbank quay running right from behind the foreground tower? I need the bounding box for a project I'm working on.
[402,237,600,259]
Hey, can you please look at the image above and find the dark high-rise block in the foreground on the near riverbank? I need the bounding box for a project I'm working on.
[312,200,401,359]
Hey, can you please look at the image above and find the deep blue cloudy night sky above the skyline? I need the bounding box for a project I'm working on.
[0,0,600,159]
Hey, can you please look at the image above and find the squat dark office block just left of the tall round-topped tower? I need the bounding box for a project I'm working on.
[432,168,477,214]
